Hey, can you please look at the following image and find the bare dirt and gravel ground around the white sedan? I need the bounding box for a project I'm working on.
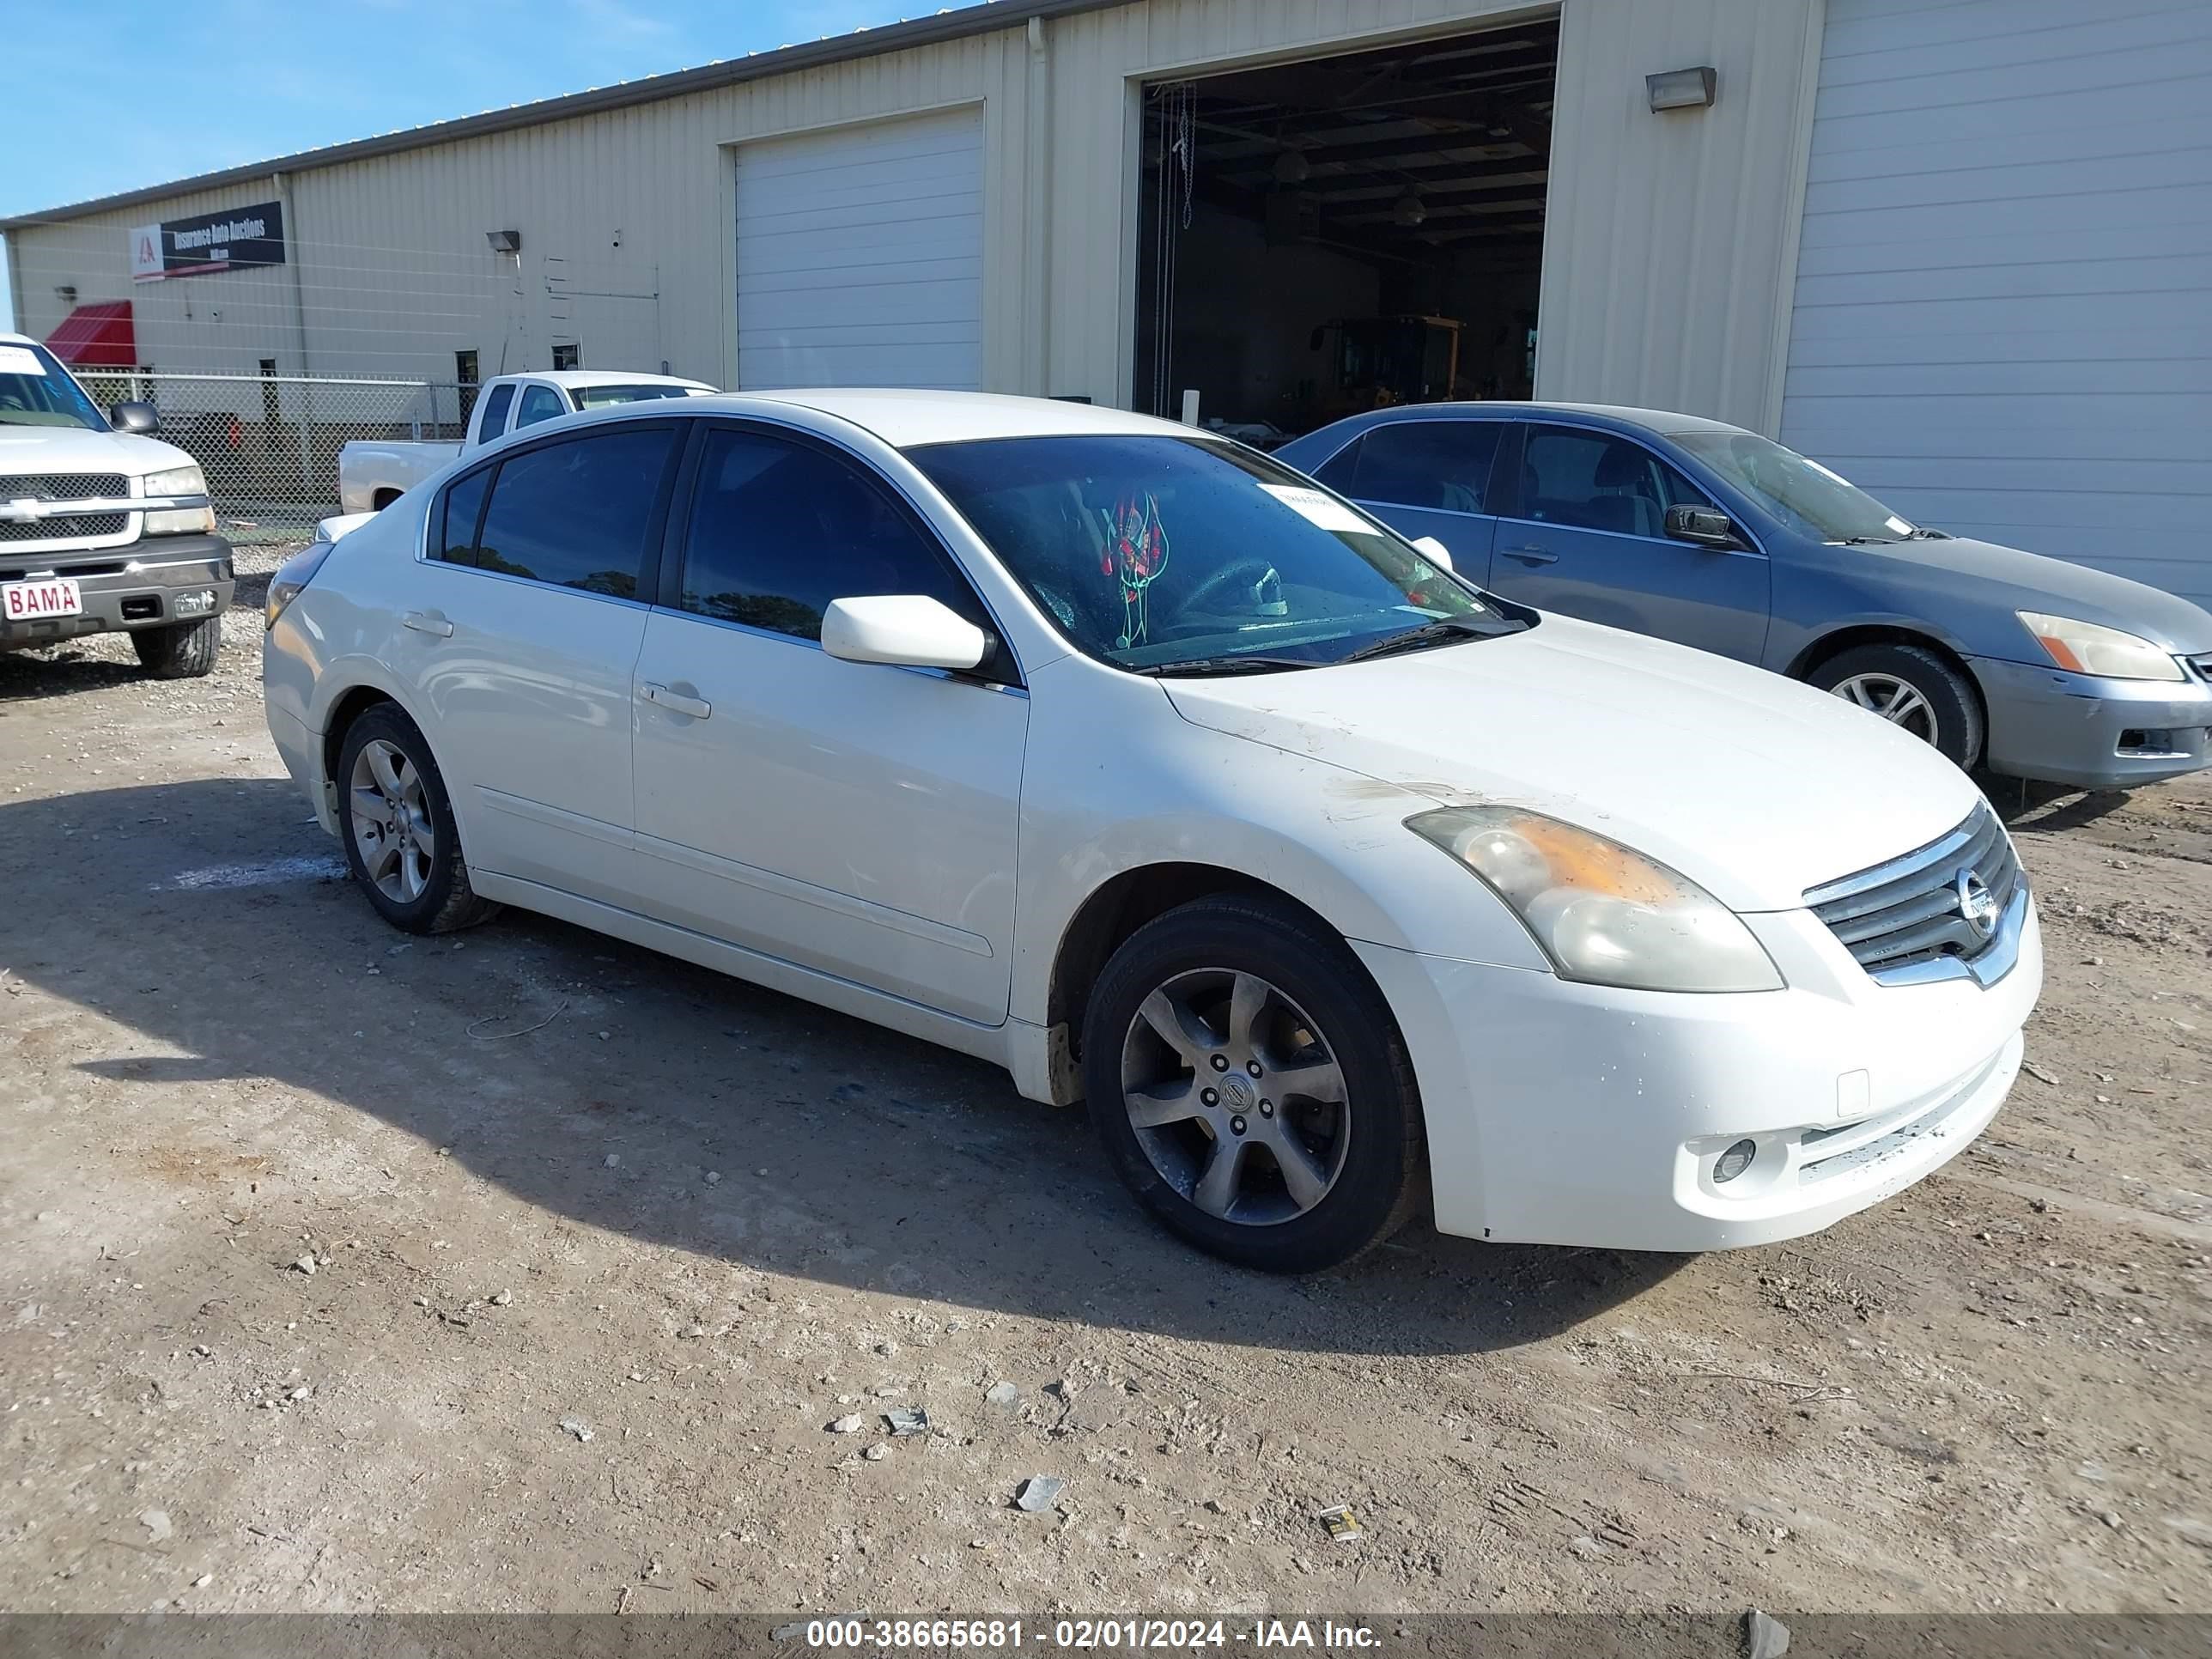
[0,556,2212,1614]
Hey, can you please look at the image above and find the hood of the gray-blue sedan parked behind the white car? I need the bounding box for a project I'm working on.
[1829,535,2212,665]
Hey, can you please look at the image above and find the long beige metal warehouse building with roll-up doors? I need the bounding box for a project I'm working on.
[13,0,2212,602]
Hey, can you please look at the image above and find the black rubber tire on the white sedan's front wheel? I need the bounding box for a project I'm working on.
[1084,896,1425,1274]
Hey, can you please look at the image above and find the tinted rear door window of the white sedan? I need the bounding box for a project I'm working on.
[476,427,675,599]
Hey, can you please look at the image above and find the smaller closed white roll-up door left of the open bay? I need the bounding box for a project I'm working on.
[737,111,982,392]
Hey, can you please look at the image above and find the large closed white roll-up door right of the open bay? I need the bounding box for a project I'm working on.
[1781,0,2212,604]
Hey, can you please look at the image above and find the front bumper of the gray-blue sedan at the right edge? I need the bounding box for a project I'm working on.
[1966,657,2212,790]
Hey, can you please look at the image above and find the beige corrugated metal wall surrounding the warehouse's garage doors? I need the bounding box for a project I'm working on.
[13,0,1820,429]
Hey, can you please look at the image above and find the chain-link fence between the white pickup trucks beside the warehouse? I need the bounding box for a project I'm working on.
[77,369,476,546]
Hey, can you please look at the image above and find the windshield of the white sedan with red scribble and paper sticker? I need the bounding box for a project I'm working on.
[907,434,1526,675]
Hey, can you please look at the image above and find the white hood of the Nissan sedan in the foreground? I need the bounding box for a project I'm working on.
[1161,615,1980,911]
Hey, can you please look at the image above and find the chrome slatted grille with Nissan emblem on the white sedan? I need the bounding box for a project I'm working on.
[1805,803,2028,980]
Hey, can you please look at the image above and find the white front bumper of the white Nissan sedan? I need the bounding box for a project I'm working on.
[1354,900,2044,1252]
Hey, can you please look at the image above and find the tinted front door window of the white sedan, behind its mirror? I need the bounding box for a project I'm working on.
[681,427,988,639]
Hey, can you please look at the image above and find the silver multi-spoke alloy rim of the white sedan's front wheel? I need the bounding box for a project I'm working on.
[1121,969,1352,1228]
